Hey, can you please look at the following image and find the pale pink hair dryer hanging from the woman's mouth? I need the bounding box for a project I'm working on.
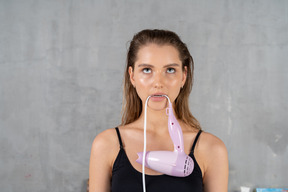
[136,101,194,177]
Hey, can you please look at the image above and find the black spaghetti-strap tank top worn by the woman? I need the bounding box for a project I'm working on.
[111,127,203,192]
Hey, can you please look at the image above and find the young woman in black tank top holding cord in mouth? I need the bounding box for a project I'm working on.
[89,30,228,192]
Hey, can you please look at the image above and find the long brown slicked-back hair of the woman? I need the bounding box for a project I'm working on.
[122,29,201,129]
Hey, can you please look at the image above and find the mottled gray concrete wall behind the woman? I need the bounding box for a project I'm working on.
[0,0,288,192]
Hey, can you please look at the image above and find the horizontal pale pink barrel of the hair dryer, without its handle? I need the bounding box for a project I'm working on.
[136,151,194,177]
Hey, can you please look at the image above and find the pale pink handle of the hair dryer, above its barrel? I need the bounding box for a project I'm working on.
[166,103,184,153]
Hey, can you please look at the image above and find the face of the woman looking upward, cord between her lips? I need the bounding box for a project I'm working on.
[129,44,187,110]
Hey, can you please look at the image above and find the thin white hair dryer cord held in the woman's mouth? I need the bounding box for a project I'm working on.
[142,95,170,192]
